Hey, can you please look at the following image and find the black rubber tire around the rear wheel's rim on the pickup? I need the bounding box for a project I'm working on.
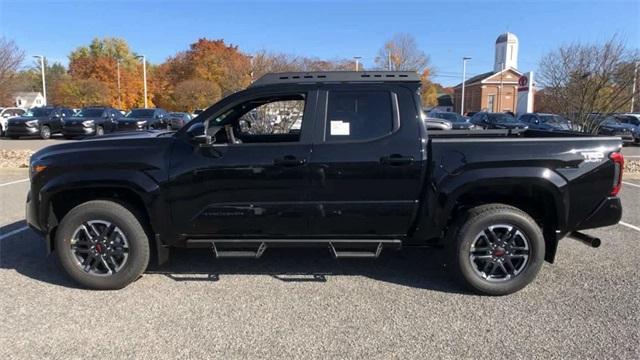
[448,204,545,296]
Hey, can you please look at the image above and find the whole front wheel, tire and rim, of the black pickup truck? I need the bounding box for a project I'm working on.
[55,200,149,290]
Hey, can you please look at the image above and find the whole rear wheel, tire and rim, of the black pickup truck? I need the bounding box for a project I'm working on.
[451,204,545,295]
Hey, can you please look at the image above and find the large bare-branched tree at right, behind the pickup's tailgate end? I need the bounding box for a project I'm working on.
[538,37,639,133]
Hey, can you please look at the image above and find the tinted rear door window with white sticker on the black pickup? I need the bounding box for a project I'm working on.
[325,91,393,142]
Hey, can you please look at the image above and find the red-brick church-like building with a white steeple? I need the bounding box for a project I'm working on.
[453,32,523,114]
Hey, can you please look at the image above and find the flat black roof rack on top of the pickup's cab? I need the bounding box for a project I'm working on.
[249,71,420,87]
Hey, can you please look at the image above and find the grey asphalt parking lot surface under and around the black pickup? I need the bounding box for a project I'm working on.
[0,171,640,359]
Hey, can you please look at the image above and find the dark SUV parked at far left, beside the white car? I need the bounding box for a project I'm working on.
[6,106,73,139]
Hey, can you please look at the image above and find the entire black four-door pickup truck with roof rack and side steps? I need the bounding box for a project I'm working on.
[27,72,623,295]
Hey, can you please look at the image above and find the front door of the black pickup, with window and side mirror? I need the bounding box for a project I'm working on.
[169,90,317,238]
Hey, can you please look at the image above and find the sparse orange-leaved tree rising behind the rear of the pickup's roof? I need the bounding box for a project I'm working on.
[375,33,430,73]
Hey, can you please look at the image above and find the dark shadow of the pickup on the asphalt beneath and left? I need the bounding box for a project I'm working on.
[0,221,464,293]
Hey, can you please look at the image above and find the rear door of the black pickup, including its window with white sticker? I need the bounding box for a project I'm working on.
[309,85,425,237]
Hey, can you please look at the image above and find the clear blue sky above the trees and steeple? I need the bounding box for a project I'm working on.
[0,0,640,85]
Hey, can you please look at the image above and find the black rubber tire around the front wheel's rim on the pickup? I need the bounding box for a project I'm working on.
[55,200,149,290]
